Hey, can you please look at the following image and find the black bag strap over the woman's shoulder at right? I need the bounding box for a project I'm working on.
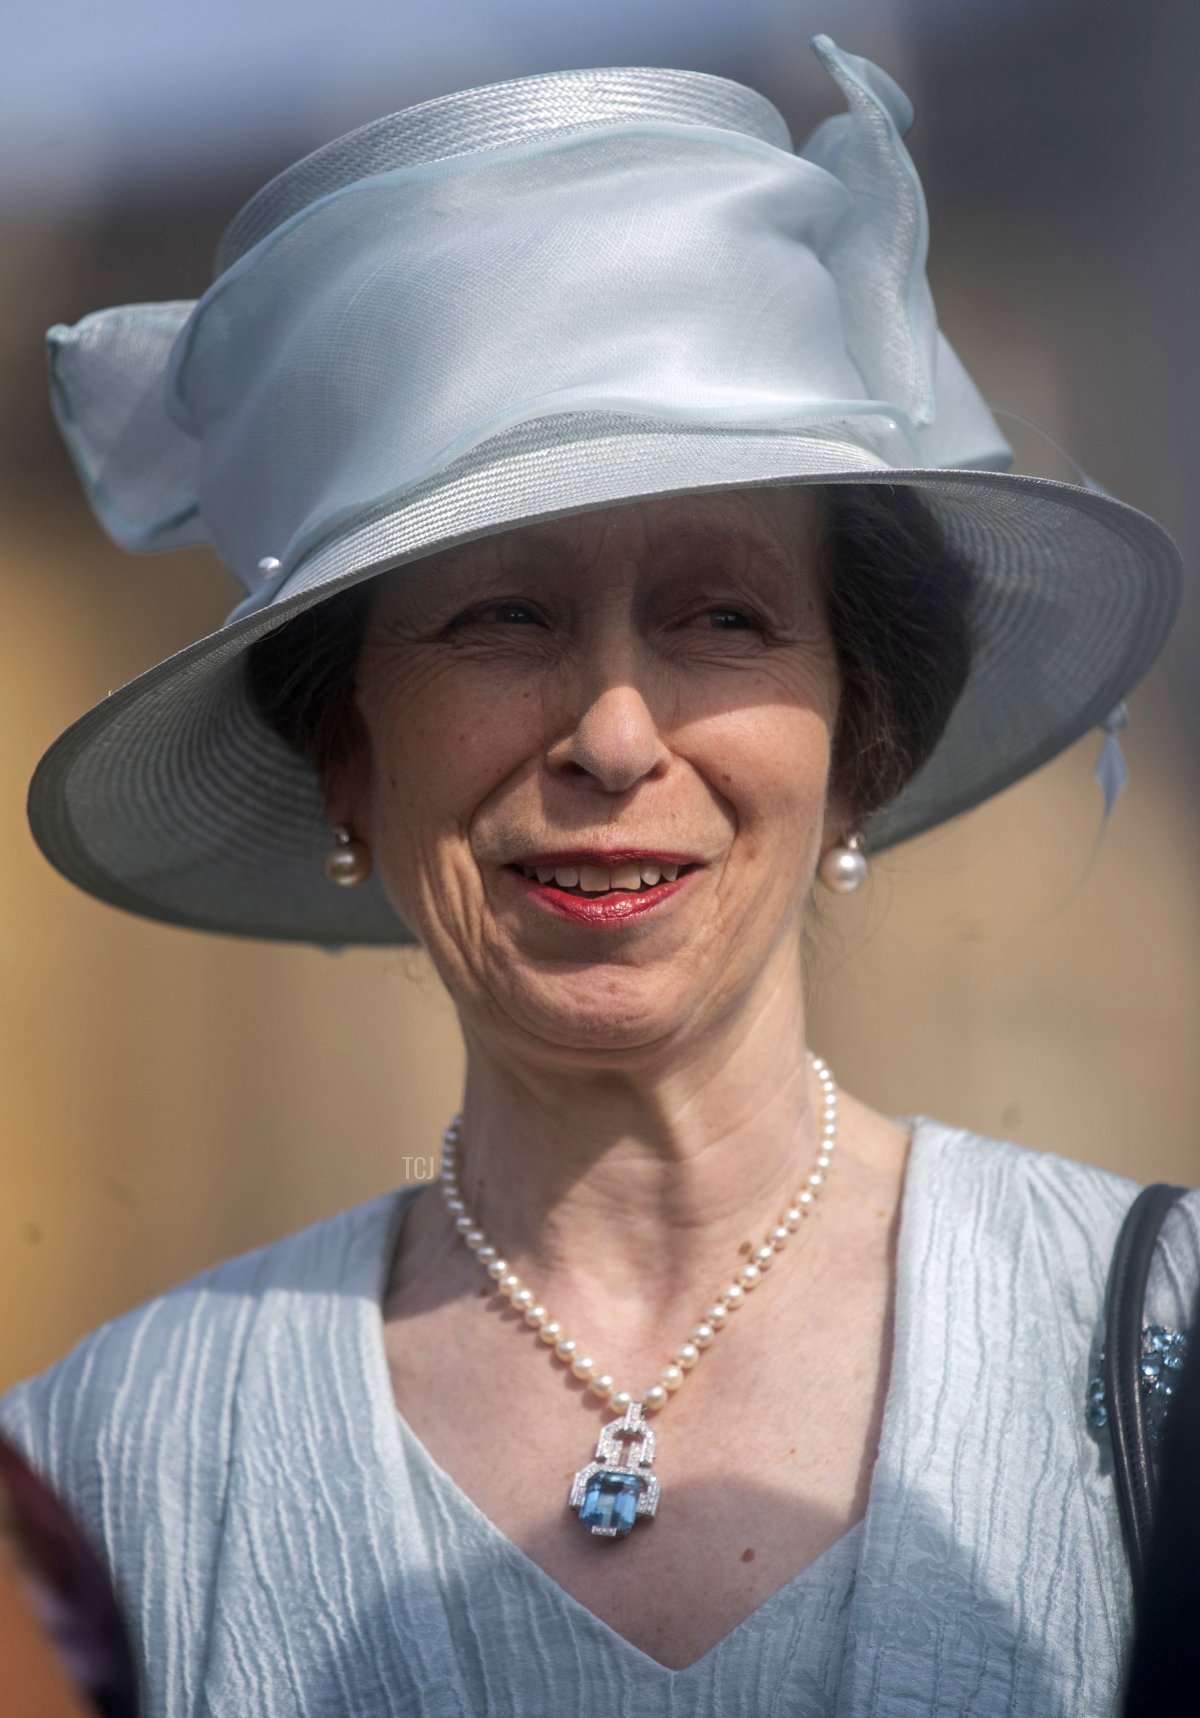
[1104,1182,1185,1601]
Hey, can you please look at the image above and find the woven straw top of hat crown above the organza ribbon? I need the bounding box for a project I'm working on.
[217,67,793,275]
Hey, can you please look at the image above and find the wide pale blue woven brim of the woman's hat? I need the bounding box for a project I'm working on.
[29,414,1181,947]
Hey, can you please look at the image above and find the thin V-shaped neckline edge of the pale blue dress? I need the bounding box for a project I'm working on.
[355,1117,928,1685]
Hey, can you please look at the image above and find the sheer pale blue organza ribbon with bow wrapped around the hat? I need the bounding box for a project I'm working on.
[42,38,1011,600]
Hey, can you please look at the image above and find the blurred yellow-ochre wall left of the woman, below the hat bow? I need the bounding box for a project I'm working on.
[0,505,459,1386]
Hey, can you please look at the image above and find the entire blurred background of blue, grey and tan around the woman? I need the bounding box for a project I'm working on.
[0,0,1200,1388]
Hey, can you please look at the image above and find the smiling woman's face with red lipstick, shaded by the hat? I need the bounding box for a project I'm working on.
[328,490,837,1055]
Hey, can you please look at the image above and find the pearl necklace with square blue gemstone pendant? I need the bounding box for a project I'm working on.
[434,1053,837,1539]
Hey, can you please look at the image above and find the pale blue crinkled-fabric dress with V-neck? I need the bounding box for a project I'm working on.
[0,1118,1200,1718]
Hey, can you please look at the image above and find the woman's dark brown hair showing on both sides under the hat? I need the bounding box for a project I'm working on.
[246,484,975,823]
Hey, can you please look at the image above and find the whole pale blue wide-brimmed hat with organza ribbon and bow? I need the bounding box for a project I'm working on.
[29,36,1181,945]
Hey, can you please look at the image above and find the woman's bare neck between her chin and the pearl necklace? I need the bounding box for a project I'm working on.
[434,960,820,1340]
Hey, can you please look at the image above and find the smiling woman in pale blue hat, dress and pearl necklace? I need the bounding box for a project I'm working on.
[3,26,1200,1715]
